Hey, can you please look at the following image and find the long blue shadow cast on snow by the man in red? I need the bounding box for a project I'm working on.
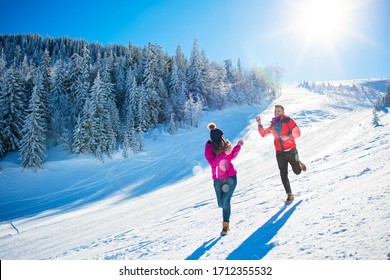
[226,200,302,260]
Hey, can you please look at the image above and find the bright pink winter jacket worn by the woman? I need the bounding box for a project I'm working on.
[204,140,241,180]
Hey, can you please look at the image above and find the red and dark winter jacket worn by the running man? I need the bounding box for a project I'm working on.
[258,115,301,152]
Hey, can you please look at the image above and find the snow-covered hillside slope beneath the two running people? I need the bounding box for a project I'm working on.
[0,81,390,260]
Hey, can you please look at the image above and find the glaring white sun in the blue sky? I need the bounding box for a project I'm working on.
[294,0,349,44]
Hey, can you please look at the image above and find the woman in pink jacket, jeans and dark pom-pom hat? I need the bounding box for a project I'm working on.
[204,123,244,236]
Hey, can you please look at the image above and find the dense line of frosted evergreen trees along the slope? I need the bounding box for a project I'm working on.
[0,34,282,169]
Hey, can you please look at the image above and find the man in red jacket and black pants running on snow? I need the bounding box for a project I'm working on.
[256,105,306,202]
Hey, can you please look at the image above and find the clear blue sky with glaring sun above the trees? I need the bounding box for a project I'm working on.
[0,0,390,81]
